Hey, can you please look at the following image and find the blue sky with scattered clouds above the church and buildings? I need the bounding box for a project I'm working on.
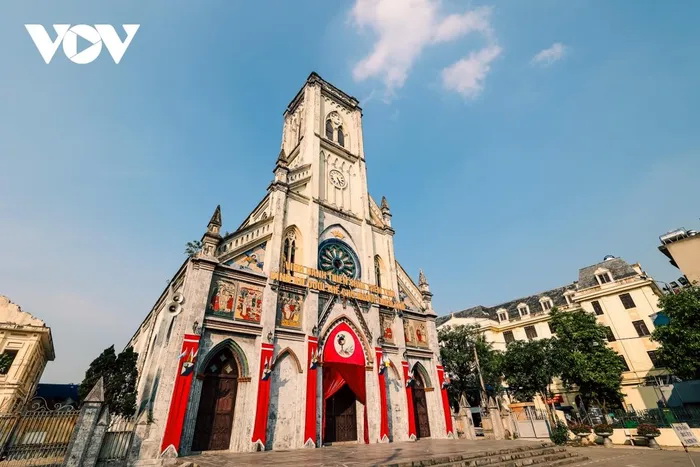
[0,0,700,382]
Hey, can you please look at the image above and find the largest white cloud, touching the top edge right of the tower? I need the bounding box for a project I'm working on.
[351,0,492,94]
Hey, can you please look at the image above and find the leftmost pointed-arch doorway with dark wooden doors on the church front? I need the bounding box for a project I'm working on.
[192,349,238,451]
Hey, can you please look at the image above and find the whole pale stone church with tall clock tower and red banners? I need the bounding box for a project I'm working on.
[129,73,453,458]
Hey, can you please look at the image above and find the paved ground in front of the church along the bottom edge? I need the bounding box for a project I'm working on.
[182,439,700,467]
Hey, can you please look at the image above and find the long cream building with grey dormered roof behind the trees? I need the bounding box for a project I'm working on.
[437,256,666,409]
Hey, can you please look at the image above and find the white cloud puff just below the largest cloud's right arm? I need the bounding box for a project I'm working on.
[442,45,502,99]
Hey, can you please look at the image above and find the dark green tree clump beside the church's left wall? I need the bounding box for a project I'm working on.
[78,345,138,416]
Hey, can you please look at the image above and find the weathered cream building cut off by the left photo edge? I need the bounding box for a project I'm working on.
[0,295,55,412]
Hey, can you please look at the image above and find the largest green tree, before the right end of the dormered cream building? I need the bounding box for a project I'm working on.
[550,308,623,410]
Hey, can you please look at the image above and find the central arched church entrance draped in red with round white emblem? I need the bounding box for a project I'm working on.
[322,322,369,443]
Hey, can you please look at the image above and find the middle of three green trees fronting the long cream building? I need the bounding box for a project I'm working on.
[502,339,560,401]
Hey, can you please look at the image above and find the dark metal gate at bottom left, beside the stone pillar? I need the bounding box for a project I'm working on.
[0,399,80,467]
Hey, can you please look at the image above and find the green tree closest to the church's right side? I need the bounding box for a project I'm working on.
[438,325,502,406]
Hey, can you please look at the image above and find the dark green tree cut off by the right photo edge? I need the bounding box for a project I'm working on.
[651,286,700,379]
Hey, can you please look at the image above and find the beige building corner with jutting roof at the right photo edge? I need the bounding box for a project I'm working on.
[659,229,700,289]
